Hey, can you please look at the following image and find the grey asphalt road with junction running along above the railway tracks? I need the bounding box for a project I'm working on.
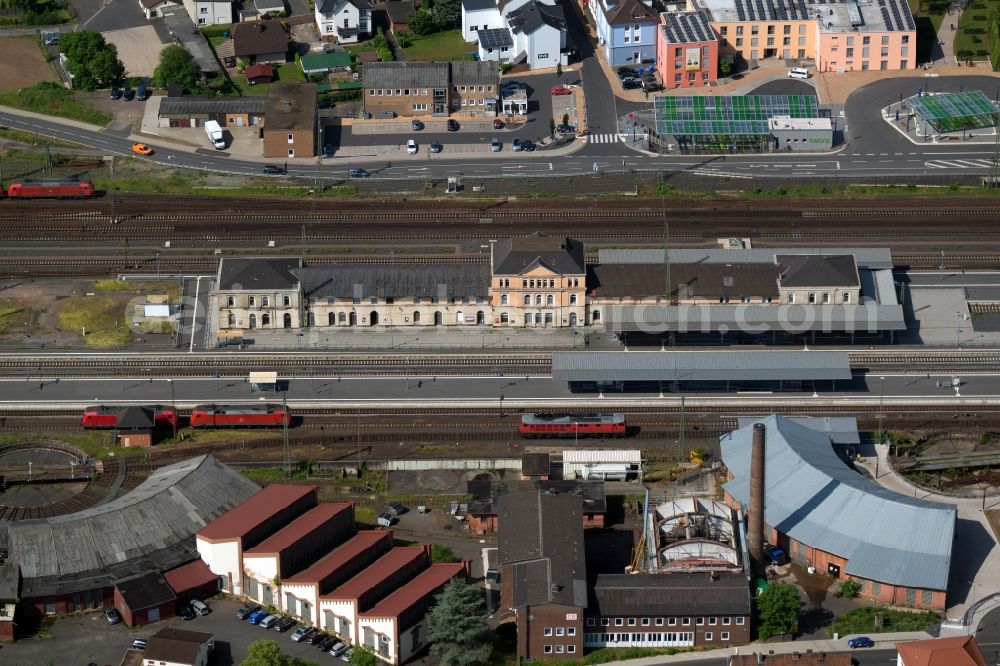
[0,75,997,181]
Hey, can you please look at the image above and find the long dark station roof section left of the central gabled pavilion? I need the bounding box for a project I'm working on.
[299,264,490,300]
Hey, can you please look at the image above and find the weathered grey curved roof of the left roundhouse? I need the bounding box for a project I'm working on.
[0,456,259,598]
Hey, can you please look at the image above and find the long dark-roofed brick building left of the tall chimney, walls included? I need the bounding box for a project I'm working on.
[497,491,587,659]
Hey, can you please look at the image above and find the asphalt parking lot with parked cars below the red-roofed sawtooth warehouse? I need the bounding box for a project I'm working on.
[0,597,354,666]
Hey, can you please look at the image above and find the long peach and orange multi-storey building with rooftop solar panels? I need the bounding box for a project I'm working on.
[687,0,917,72]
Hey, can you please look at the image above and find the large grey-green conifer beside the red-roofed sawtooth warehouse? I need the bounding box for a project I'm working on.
[427,578,493,666]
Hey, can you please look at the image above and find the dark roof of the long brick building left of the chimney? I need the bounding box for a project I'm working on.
[497,491,587,608]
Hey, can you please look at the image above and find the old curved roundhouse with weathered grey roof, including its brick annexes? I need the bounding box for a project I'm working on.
[0,456,260,638]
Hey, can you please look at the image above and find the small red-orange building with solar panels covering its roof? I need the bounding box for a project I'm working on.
[656,10,719,89]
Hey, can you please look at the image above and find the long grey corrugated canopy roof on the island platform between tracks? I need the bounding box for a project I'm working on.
[552,351,851,382]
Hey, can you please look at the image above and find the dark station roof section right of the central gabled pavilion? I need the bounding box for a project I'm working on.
[587,264,781,302]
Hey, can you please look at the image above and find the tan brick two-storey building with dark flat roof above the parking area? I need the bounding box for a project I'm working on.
[361,62,449,118]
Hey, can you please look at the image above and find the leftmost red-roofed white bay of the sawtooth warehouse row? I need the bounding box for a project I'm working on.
[195,484,317,594]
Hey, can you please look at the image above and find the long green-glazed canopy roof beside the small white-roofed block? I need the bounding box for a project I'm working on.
[653,95,823,136]
